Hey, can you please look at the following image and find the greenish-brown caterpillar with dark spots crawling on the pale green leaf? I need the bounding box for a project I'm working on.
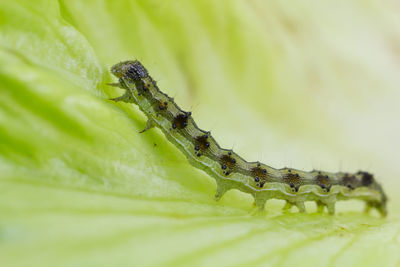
[109,60,387,217]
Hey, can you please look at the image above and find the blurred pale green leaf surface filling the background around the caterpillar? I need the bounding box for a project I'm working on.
[0,0,400,266]
